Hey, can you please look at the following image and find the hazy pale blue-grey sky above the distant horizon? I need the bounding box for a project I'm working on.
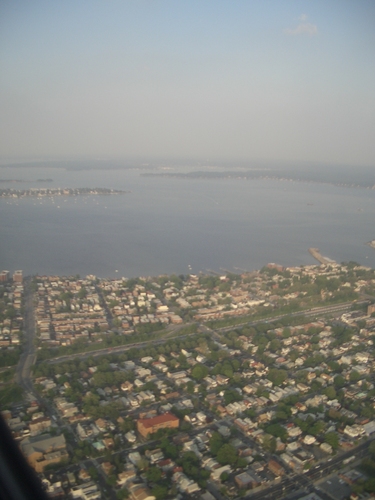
[0,0,375,165]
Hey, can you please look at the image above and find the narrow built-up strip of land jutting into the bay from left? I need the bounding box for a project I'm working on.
[0,188,126,198]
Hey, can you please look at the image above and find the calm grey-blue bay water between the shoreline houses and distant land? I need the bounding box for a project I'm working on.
[0,168,375,277]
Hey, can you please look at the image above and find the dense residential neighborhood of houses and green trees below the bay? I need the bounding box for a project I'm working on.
[1,262,375,500]
